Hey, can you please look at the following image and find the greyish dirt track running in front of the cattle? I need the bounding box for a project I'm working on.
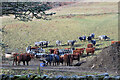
[0,59,116,75]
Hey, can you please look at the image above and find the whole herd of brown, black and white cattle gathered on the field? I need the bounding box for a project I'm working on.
[5,33,113,66]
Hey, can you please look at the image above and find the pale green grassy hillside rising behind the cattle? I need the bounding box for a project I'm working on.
[2,3,118,53]
